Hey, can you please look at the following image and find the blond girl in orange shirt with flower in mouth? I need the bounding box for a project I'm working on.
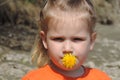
[22,0,111,80]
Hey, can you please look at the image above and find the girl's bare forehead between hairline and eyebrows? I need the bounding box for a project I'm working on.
[48,12,88,30]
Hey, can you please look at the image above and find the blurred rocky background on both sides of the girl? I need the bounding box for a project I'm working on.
[0,0,120,80]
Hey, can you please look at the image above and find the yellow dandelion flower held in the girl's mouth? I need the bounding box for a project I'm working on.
[62,53,76,68]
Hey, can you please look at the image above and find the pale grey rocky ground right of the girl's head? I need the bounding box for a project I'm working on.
[87,24,120,80]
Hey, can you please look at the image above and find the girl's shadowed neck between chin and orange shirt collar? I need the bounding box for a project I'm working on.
[51,64,85,78]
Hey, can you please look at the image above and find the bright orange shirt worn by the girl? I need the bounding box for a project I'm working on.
[22,65,111,80]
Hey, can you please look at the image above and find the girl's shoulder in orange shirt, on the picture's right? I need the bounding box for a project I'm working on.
[86,68,112,80]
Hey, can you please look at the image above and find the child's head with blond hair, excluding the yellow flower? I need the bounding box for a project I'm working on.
[33,0,96,70]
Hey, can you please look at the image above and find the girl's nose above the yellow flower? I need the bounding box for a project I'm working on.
[63,41,73,54]
